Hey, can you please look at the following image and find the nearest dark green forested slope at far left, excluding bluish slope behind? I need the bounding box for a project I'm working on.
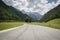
[0,0,18,20]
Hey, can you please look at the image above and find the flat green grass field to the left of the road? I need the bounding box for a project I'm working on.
[0,22,23,30]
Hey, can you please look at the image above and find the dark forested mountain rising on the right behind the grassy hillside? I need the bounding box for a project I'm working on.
[40,5,60,22]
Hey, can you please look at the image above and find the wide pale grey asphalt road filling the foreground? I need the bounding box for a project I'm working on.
[0,24,60,40]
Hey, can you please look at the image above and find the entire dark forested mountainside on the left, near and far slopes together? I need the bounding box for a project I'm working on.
[0,0,28,21]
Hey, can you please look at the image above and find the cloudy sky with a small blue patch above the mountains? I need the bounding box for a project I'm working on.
[3,0,60,15]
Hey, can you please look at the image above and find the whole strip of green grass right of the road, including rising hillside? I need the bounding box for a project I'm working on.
[31,18,60,29]
